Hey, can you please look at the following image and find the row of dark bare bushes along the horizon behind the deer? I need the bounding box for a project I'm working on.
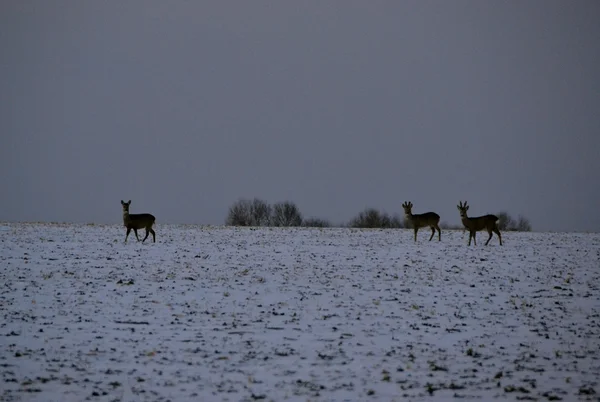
[225,198,531,232]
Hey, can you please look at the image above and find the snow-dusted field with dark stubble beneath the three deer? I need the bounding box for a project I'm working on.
[0,224,600,402]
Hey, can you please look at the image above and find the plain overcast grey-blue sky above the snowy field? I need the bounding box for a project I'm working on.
[0,0,600,231]
